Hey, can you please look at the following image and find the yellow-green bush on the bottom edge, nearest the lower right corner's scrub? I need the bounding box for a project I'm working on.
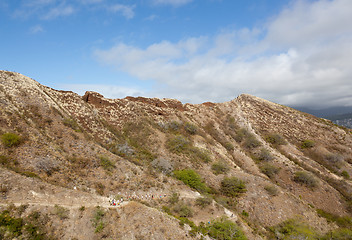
[271,219,318,240]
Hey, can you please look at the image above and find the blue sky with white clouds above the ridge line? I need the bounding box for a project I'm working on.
[0,0,352,108]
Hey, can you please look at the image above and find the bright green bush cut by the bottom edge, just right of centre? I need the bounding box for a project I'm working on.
[207,217,247,240]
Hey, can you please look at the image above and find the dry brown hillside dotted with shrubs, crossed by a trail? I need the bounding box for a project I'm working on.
[0,71,352,240]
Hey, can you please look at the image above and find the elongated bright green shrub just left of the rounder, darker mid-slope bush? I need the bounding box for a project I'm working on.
[174,169,210,192]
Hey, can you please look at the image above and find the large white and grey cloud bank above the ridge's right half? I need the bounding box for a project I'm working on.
[95,0,352,106]
